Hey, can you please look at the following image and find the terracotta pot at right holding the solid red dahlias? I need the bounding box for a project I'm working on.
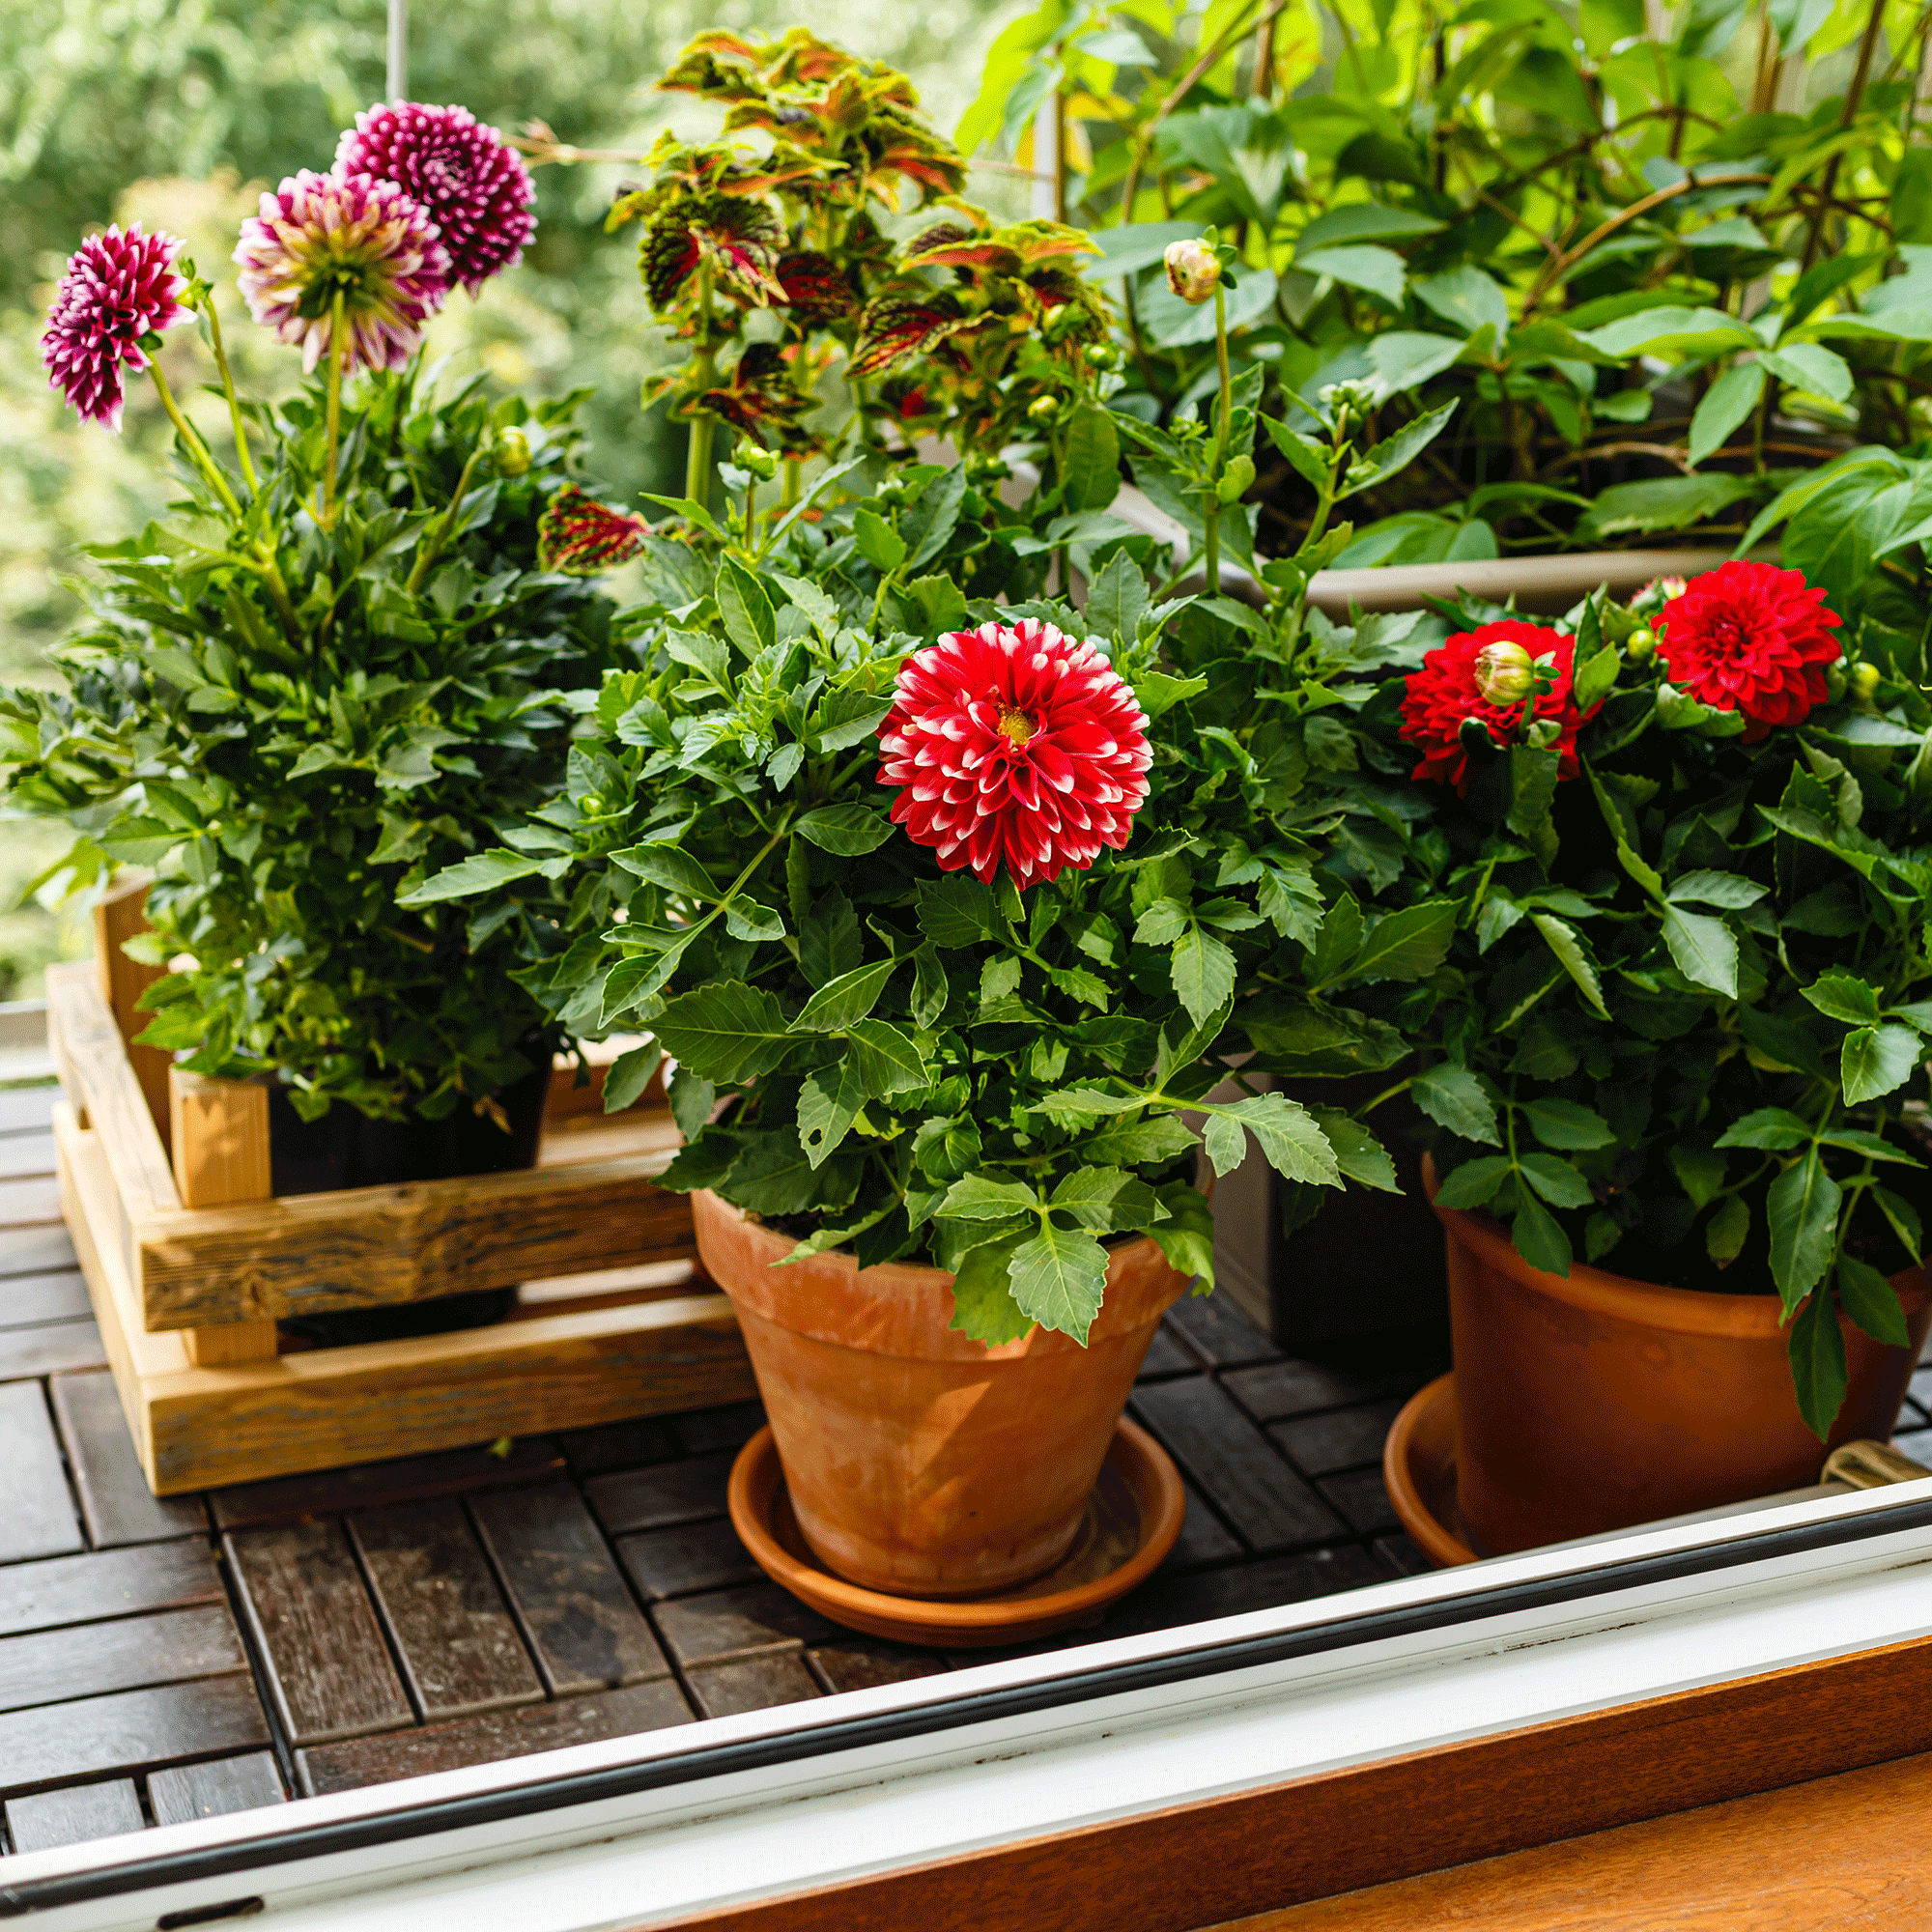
[1424,1163,1932,1555]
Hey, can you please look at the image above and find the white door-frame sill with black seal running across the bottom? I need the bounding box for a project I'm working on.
[14,1478,1932,1932]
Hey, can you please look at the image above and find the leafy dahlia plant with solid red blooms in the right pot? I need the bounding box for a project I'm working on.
[1391,562,1932,1437]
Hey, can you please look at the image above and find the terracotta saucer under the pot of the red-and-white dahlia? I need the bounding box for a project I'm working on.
[730,1416,1186,1650]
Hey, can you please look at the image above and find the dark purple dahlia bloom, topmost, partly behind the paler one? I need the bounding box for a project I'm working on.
[336,100,537,296]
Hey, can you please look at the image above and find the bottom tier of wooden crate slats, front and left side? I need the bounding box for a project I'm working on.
[54,1107,753,1495]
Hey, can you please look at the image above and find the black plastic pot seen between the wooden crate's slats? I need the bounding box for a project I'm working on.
[269,1036,551,1349]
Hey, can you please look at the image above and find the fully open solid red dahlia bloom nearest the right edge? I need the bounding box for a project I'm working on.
[1658,562,1841,738]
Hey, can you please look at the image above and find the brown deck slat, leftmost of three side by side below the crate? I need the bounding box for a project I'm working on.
[224,1519,413,1745]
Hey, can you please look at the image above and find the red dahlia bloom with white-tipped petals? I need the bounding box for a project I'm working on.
[879,618,1153,887]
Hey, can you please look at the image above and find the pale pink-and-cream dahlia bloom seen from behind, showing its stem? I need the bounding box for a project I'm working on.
[234,168,450,375]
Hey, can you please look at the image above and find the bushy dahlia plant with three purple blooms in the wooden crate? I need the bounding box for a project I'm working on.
[0,102,612,1119]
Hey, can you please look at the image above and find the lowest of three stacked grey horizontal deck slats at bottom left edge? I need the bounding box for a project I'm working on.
[0,1675,269,1797]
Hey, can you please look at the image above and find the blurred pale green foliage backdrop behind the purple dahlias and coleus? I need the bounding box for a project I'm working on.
[0,0,1014,999]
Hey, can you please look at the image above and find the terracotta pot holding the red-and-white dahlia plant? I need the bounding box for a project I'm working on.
[692,1192,1186,1598]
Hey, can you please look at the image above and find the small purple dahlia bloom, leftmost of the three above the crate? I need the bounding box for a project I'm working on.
[41,222,187,431]
